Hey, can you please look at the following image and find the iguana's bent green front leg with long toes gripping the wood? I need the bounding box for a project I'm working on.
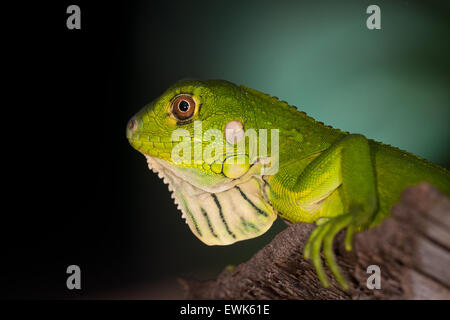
[294,135,377,289]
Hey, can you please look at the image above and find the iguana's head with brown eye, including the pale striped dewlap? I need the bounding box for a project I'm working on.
[127,80,276,245]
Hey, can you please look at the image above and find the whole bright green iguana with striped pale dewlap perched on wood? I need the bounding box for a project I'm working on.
[127,80,450,288]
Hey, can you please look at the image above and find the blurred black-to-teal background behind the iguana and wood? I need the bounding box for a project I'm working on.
[0,1,450,298]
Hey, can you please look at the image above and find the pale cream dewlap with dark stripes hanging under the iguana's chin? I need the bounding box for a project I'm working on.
[145,155,277,245]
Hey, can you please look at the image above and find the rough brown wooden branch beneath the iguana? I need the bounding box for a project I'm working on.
[181,183,450,299]
